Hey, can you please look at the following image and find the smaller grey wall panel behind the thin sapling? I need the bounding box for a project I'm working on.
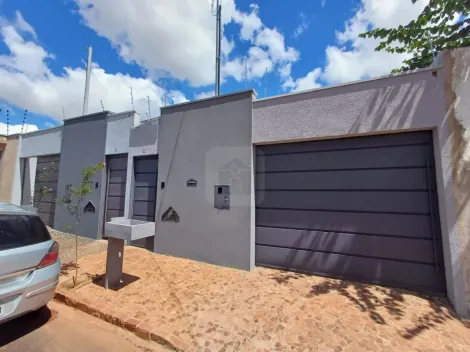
[54,112,108,238]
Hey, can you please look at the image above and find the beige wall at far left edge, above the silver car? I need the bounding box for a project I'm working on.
[0,136,19,202]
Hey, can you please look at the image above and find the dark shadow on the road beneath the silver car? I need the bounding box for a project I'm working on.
[0,307,57,347]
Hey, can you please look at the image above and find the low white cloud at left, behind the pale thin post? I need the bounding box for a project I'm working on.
[0,15,189,120]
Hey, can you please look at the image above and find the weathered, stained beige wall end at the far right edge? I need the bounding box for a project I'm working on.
[443,48,470,314]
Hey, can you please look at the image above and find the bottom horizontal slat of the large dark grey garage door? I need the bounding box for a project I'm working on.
[256,246,445,293]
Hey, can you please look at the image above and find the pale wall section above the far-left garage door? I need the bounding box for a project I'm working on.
[20,126,62,158]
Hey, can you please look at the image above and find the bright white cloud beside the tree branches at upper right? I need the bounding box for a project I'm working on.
[322,0,428,83]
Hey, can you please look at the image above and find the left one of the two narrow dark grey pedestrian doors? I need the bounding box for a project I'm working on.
[106,154,127,221]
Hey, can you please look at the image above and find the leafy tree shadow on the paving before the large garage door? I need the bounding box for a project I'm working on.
[272,272,470,339]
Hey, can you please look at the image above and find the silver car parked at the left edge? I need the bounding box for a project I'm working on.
[0,203,61,324]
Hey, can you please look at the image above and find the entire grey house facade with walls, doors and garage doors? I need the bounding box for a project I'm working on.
[0,48,470,316]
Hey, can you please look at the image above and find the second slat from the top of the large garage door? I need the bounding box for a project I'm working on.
[256,168,426,190]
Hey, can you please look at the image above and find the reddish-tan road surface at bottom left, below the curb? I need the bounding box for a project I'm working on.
[0,302,169,352]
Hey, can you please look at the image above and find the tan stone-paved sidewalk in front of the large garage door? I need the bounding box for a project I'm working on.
[59,247,470,352]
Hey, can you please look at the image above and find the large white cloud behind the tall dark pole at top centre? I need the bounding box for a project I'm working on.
[75,0,299,86]
